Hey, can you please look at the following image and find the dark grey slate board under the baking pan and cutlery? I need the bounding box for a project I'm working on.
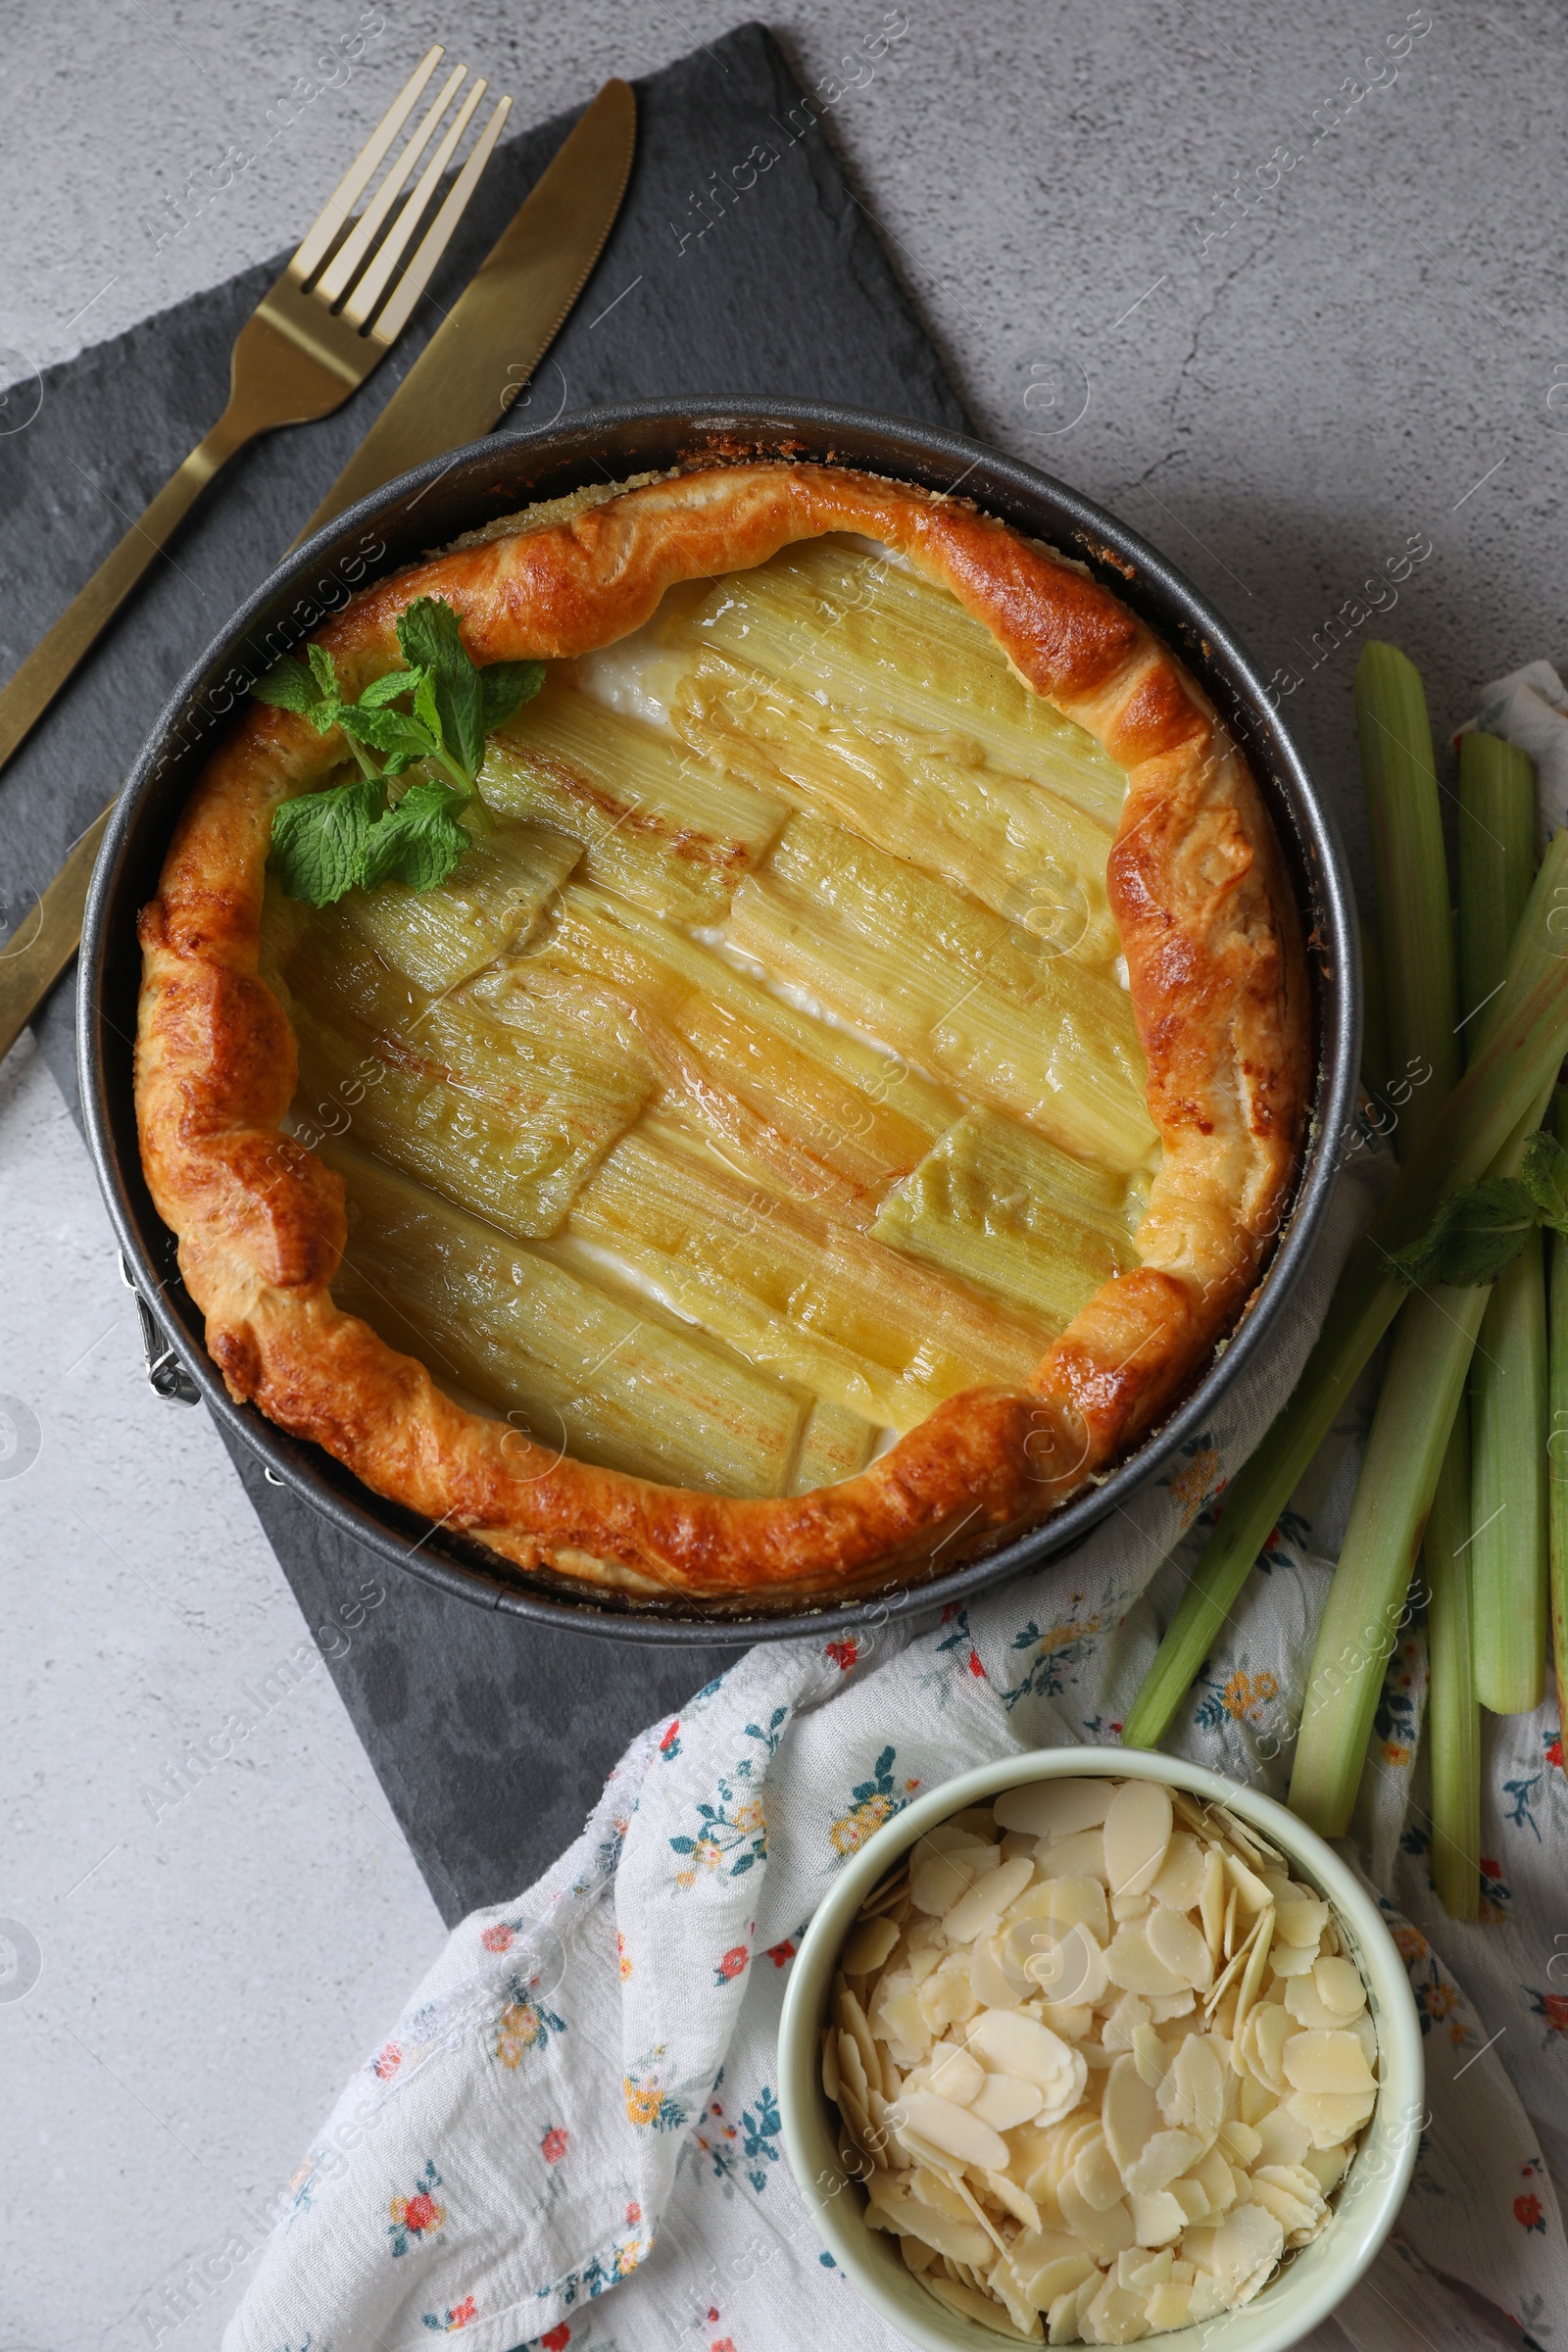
[0,24,966,1919]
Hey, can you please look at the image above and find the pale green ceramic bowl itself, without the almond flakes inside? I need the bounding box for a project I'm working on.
[778,1747,1425,2352]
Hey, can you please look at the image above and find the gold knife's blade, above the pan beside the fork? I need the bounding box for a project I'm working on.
[289,80,637,553]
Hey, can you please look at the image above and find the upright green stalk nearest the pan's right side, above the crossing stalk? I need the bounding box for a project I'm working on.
[1356,642,1460,1162]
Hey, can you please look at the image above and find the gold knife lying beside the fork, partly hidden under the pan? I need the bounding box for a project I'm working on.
[0,80,637,1058]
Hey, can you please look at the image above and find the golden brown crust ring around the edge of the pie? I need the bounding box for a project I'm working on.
[136,464,1309,1599]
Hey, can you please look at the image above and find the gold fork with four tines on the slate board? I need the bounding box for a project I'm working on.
[0,47,513,780]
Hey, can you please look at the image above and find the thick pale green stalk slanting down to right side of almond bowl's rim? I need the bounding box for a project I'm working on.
[1291,1289,1486,1837]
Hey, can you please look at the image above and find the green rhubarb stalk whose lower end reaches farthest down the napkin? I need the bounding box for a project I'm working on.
[1422,1399,1481,1919]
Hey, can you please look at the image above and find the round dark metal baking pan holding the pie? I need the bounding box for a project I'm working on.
[77,400,1359,1642]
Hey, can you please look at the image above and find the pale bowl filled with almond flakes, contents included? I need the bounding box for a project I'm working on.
[778,1747,1425,2352]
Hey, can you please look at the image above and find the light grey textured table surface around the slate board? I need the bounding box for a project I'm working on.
[0,0,1568,2352]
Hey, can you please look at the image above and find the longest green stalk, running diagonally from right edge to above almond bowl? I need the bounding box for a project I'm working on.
[1121,828,1568,1747]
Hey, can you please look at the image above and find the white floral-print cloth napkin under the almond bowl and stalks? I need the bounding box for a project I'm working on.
[223,691,1568,2352]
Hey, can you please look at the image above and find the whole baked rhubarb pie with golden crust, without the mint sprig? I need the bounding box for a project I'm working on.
[136,464,1309,1606]
